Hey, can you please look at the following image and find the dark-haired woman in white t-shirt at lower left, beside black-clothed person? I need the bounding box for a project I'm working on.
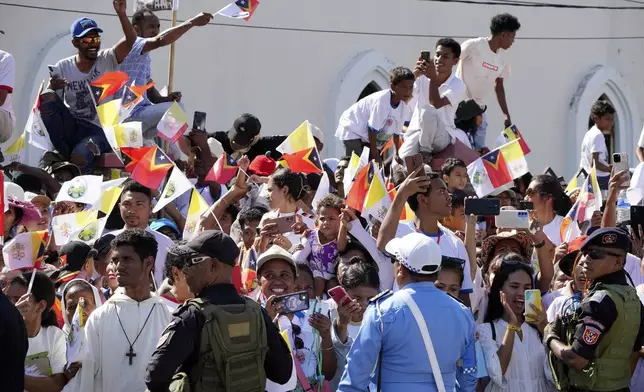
[7,271,67,392]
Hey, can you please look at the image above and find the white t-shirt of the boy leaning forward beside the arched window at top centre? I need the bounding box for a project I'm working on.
[335,90,410,148]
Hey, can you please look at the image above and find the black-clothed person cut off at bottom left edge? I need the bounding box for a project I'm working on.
[0,291,29,392]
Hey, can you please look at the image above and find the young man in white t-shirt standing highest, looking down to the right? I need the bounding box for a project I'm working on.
[456,14,521,149]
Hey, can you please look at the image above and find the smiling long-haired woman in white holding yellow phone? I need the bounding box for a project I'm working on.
[476,253,555,392]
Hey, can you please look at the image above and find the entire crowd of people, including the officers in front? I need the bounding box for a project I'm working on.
[0,0,644,392]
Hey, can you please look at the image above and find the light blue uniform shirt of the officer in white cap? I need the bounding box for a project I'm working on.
[338,282,476,392]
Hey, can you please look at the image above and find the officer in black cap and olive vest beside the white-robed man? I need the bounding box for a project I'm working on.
[145,230,293,392]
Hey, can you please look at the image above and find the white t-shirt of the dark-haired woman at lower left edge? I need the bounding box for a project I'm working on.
[25,327,67,376]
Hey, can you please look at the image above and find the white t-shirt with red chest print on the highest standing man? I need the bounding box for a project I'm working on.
[456,37,510,106]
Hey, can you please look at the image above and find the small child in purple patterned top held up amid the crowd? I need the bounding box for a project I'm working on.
[293,195,347,298]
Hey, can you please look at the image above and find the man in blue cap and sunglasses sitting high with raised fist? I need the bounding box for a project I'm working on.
[40,0,136,172]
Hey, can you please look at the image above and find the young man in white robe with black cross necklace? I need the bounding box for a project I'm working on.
[64,229,172,392]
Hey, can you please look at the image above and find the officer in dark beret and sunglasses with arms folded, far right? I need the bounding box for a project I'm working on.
[543,227,644,391]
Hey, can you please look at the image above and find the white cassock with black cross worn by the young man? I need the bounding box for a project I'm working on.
[63,290,172,392]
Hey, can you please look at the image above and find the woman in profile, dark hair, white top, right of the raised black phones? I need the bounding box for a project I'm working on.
[525,174,572,246]
